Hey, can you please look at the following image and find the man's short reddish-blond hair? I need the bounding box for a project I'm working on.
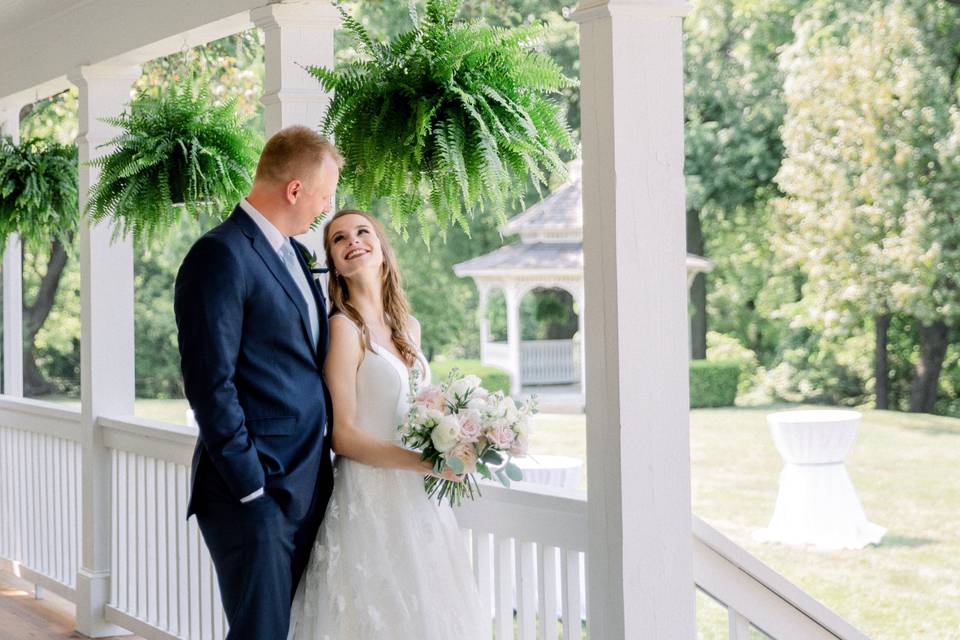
[255,125,343,183]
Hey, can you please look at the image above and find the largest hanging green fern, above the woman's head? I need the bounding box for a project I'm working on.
[307,0,575,240]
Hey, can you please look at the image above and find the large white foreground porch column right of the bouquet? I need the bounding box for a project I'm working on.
[574,0,696,640]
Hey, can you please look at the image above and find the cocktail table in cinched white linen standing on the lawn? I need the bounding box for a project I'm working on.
[754,409,886,549]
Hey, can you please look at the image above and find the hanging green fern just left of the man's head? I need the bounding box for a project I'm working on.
[87,80,262,239]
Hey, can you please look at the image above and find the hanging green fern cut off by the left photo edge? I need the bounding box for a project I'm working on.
[0,137,80,250]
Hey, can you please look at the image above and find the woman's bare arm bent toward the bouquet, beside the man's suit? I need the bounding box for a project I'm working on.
[323,318,433,475]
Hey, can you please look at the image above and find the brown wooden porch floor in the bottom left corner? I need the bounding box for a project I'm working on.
[0,571,143,640]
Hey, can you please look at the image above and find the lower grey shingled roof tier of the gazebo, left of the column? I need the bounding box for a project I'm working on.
[453,242,583,278]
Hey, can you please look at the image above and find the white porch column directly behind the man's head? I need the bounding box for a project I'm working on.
[250,0,340,262]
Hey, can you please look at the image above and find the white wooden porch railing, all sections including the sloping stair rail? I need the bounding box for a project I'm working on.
[0,398,866,640]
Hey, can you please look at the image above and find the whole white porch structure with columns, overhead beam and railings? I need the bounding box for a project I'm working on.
[0,0,865,640]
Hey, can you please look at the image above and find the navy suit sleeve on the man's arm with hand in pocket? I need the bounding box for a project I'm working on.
[174,236,265,501]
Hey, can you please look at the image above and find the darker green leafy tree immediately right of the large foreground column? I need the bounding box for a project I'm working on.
[684,0,802,358]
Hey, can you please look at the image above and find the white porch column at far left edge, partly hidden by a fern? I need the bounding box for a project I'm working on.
[0,102,23,396]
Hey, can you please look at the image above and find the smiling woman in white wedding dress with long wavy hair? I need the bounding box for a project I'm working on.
[289,209,490,640]
